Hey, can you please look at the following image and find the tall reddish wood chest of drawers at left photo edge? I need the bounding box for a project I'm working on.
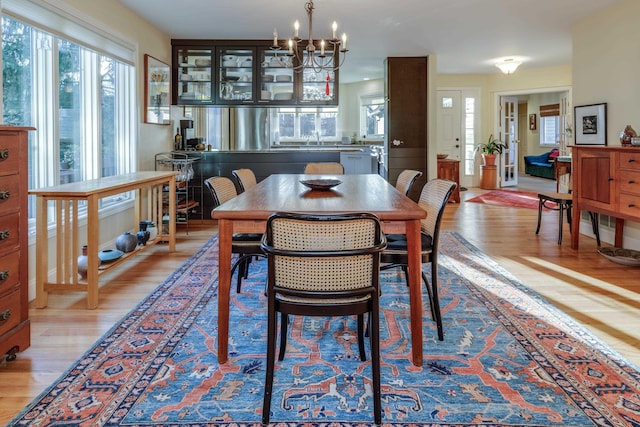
[0,126,34,360]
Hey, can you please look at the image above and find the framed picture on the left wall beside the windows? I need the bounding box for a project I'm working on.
[144,55,171,125]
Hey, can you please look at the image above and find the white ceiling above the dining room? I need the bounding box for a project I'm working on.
[120,0,621,83]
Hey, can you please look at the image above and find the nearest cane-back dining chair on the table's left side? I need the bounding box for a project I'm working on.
[204,176,264,293]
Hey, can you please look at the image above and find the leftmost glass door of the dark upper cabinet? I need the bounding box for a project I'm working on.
[174,48,214,104]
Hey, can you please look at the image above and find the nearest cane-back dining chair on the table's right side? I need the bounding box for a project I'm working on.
[381,178,457,341]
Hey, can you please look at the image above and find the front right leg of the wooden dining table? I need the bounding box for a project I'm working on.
[406,220,422,366]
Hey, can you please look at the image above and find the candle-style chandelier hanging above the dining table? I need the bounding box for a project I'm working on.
[271,0,349,72]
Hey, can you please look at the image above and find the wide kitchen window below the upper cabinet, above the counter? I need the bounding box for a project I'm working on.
[271,107,338,144]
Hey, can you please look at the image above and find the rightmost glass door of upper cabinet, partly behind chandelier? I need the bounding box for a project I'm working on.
[299,51,338,105]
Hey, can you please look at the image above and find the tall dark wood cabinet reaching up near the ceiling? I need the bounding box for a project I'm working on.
[385,56,428,200]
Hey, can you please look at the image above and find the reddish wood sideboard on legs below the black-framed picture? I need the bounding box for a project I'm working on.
[571,146,640,249]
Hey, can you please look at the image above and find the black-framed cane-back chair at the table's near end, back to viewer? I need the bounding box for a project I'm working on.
[262,213,386,424]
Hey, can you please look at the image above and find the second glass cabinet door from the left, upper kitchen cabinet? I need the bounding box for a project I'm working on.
[216,47,256,104]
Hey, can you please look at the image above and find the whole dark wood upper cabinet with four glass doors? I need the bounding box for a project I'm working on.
[171,39,338,106]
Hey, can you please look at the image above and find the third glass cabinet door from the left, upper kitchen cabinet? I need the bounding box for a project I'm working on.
[258,48,295,104]
